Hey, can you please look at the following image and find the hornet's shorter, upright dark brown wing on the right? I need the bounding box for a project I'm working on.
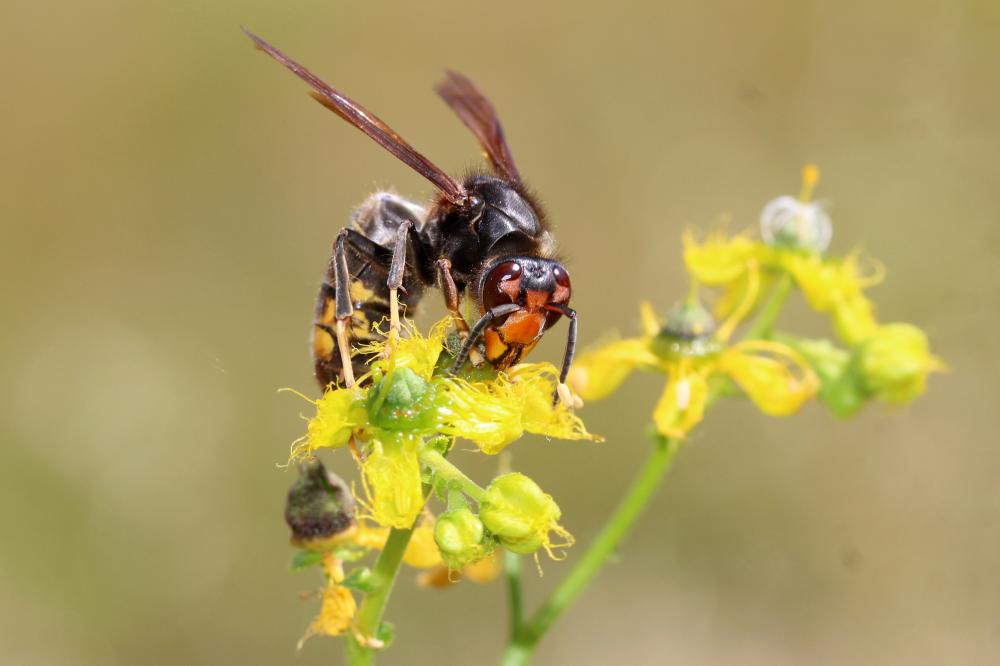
[435,70,521,183]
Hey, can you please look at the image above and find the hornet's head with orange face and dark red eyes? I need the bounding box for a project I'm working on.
[480,257,572,370]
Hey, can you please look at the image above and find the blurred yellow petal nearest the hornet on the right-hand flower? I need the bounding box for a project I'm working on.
[567,338,659,400]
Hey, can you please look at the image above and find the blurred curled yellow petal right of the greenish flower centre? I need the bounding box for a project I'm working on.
[718,340,820,416]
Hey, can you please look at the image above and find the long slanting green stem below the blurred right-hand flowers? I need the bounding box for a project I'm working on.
[501,434,681,666]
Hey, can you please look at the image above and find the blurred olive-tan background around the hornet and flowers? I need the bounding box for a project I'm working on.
[0,0,1000,666]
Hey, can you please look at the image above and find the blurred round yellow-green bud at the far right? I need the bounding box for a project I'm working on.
[853,324,945,405]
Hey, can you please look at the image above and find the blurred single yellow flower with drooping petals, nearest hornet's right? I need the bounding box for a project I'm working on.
[569,300,819,438]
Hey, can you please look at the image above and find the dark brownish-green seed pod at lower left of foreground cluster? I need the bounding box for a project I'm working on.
[285,459,357,548]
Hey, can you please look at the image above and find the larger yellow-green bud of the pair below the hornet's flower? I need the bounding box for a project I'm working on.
[479,472,572,555]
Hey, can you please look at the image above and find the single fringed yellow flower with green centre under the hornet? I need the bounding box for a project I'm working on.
[292,318,600,529]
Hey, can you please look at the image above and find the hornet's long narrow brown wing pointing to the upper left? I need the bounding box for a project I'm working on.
[243,28,467,205]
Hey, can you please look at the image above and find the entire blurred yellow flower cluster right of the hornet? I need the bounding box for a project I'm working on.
[570,165,944,428]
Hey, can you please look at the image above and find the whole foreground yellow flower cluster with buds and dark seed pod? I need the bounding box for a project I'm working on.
[285,318,599,646]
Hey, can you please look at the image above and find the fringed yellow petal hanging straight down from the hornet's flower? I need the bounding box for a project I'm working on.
[361,433,424,529]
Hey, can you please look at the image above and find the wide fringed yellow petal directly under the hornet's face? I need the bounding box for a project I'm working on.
[438,363,598,455]
